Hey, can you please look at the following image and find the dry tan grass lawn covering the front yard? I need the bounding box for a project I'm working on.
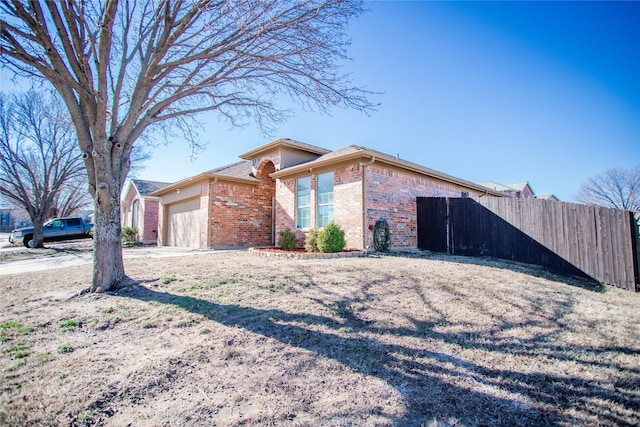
[0,251,640,426]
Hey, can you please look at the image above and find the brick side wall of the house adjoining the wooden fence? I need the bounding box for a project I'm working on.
[365,164,480,247]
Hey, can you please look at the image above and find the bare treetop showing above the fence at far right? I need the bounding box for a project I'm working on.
[576,165,640,211]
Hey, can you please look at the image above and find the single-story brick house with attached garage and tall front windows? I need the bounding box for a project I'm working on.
[151,139,508,249]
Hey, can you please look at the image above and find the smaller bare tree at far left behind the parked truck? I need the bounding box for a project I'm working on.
[0,92,89,247]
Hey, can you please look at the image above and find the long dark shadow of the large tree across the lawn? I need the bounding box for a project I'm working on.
[119,280,640,426]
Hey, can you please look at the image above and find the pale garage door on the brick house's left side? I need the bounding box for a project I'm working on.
[167,198,202,248]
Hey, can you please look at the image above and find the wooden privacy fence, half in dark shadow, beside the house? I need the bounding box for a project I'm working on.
[417,197,640,291]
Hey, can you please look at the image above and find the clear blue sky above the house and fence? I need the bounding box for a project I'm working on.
[146,1,640,201]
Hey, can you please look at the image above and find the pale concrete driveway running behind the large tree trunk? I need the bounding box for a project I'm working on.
[0,246,220,276]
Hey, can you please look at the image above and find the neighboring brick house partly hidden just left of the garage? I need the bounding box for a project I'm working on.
[122,179,169,244]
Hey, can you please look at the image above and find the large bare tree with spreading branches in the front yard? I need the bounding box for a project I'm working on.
[0,0,373,291]
